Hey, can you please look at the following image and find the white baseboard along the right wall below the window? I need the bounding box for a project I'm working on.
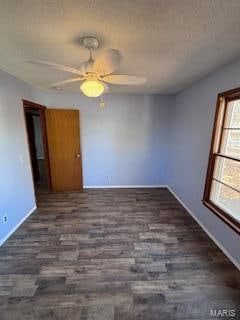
[167,186,240,270]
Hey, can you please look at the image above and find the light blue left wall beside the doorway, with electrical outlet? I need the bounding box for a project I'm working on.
[0,71,40,242]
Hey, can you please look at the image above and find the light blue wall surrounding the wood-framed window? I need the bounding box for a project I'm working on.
[167,60,240,262]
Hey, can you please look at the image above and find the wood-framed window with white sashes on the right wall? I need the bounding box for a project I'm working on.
[203,88,240,233]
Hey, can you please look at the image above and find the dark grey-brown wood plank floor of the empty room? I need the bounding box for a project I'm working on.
[0,189,240,320]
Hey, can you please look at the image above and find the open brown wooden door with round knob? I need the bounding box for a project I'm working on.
[46,109,83,191]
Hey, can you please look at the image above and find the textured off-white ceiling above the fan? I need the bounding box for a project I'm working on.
[0,0,240,94]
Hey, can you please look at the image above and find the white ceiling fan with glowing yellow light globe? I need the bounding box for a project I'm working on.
[28,36,146,97]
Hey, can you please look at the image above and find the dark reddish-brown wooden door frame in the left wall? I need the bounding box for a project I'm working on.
[22,99,52,191]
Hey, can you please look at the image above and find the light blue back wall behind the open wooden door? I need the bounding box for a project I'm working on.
[42,94,172,186]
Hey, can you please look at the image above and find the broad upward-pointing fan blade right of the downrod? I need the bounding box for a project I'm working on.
[93,49,120,75]
